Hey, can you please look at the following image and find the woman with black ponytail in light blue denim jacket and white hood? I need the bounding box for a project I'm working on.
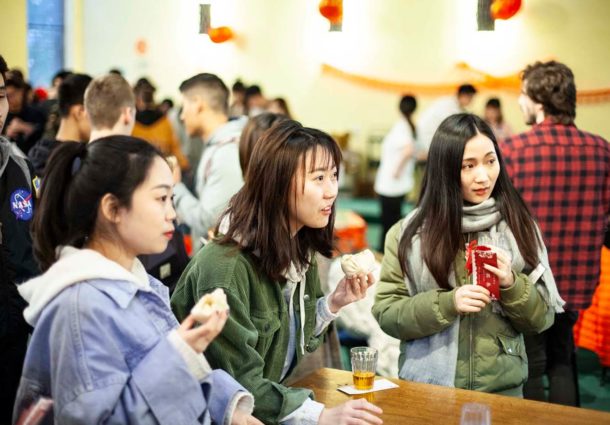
[14,136,260,425]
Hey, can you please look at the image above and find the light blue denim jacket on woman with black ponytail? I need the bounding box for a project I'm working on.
[13,247,245,425]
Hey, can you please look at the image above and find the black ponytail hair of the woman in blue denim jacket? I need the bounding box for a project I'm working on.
[32,136,161,271]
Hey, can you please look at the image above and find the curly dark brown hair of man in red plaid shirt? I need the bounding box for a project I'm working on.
[521,61,576,124]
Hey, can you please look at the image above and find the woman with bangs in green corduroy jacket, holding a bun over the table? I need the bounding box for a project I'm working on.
[172,120,382,425]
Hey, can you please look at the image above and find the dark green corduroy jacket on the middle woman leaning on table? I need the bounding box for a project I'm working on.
[171,242,324,424]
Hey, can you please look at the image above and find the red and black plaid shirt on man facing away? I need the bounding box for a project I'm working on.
[500,119,610,310]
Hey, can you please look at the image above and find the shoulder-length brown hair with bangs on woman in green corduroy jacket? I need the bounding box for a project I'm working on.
[216,120,341,280]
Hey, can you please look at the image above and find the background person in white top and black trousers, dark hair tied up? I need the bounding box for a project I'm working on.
[375,95,417,252]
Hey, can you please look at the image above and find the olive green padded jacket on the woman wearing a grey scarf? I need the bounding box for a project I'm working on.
[373,221,554,396]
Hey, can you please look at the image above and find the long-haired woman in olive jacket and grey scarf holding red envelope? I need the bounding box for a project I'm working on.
[373,114,563,396]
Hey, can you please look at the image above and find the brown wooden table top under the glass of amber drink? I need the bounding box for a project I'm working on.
[293,369,610,425]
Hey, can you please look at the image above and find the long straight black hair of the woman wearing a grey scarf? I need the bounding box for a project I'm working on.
[398,114,542,289]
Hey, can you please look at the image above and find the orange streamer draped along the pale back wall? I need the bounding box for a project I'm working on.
[322,62,610,103]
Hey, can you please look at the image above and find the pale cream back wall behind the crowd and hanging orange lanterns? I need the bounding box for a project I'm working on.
[79,0,610,148]
